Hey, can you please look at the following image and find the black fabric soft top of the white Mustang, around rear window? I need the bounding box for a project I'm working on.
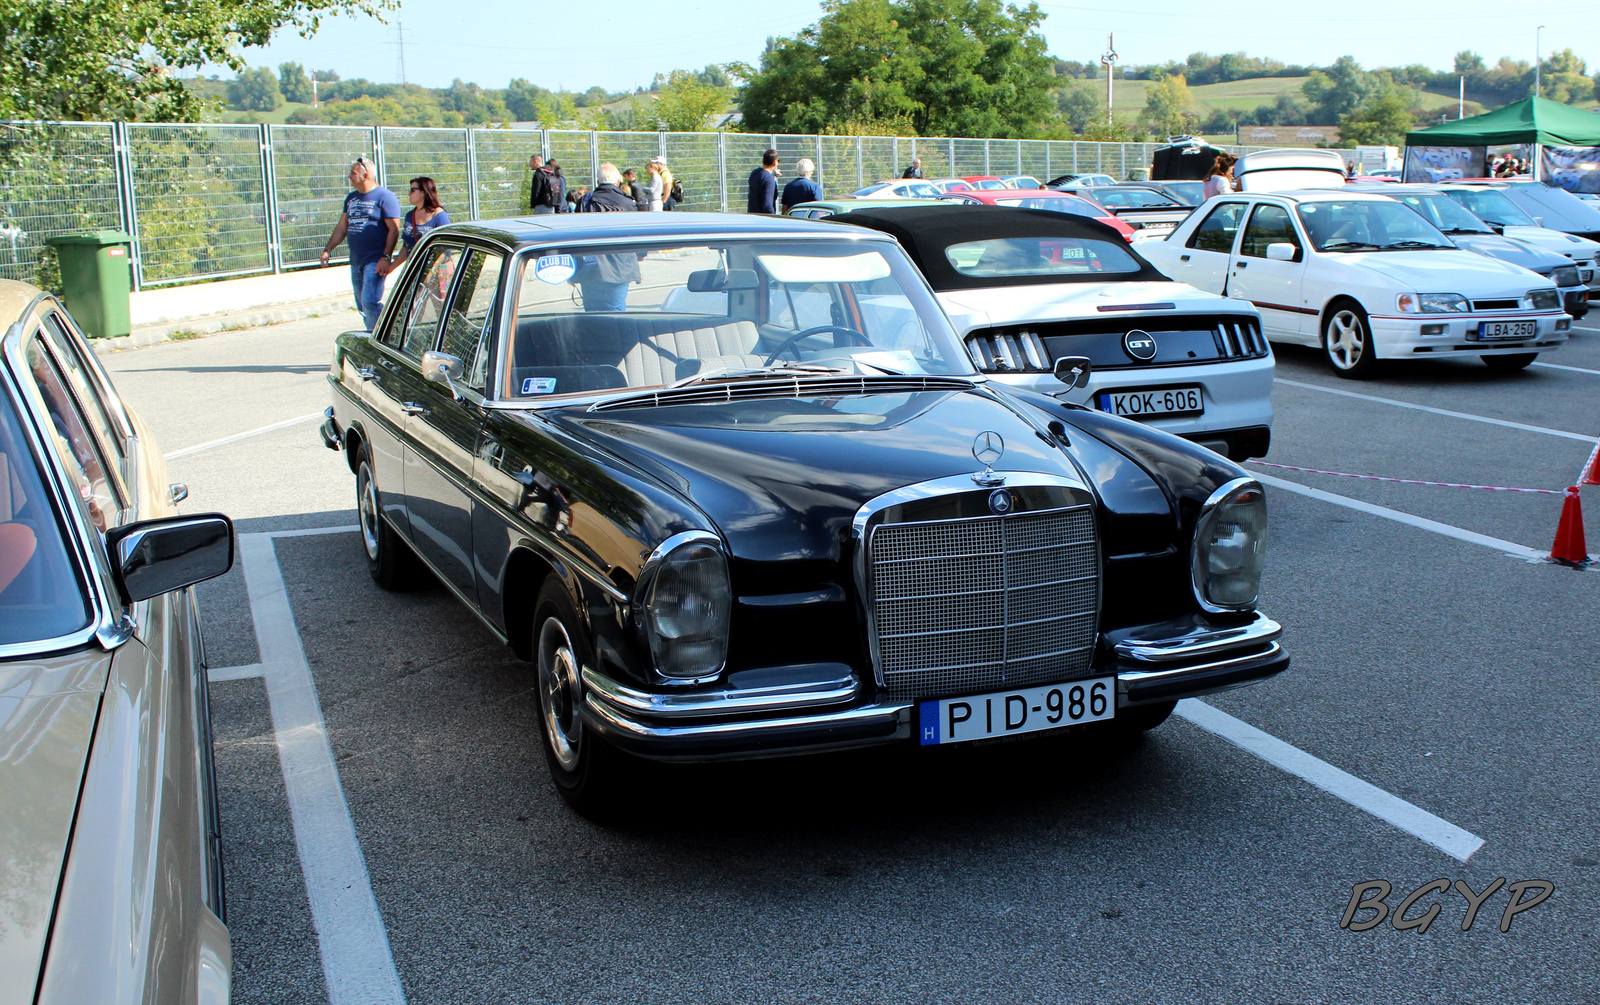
[827,205,1166,291]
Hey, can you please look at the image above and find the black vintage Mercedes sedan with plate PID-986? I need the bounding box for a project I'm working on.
[322,213,1288,813]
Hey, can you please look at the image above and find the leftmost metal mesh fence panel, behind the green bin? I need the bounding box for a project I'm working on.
[0,123,122,285]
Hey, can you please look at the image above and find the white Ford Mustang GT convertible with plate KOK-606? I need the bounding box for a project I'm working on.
[834,205,1272,461]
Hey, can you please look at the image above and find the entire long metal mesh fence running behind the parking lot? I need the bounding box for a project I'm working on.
[0,122,1262,294]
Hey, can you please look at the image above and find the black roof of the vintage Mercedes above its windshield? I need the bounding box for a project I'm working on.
[416,213,876,246]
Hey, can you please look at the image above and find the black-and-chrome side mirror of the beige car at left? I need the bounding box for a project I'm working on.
[106,514,234,603]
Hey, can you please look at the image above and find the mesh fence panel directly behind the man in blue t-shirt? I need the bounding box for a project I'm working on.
[270,126,374,267]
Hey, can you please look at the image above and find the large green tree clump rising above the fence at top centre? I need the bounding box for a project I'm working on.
[730,0,1056,136]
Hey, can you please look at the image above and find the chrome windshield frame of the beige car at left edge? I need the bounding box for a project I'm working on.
[0,325,121,659]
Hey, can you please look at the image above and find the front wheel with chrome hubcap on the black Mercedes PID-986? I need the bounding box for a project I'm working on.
[533,576,634,821]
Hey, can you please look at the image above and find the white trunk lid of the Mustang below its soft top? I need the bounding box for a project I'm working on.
[936,283,1235,334]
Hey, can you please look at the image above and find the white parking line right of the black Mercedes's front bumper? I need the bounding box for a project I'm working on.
[1178,698,1483,863]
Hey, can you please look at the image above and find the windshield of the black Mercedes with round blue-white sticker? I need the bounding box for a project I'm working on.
[502,240,973,398]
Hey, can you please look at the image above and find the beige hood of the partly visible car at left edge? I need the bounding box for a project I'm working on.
[0,651,110,1005]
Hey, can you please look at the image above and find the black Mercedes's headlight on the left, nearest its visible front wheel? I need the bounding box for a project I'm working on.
[640,531,733,677]
